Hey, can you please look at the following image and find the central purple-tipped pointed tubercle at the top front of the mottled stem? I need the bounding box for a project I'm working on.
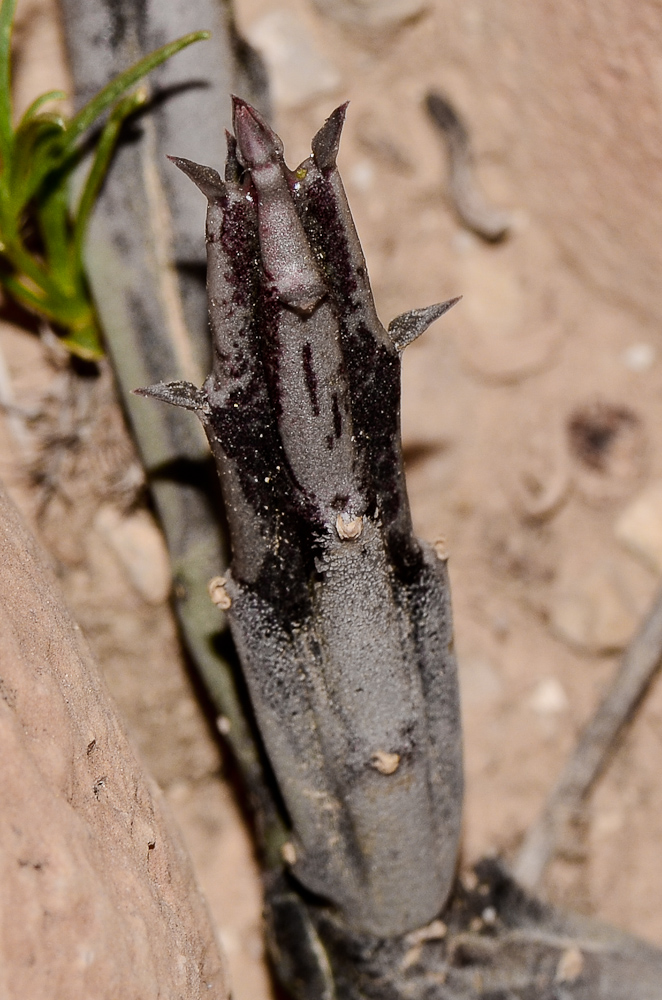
[233,97,327,315]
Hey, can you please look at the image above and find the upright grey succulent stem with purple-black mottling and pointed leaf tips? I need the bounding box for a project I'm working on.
[141,99,462,936]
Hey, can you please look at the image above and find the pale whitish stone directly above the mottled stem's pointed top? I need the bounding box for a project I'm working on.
[247,10,341,108]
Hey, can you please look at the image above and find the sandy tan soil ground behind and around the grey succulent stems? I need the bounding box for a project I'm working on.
[0,0,662,1000]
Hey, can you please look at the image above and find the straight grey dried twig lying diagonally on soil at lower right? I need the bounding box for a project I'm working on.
[513,590,662,889]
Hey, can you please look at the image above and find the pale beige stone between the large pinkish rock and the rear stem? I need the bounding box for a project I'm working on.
[94,504,171,604]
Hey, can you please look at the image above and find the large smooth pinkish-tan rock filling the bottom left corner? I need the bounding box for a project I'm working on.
[0,484,229,1000]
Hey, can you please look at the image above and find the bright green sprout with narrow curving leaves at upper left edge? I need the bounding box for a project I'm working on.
[0,0,209,360]
